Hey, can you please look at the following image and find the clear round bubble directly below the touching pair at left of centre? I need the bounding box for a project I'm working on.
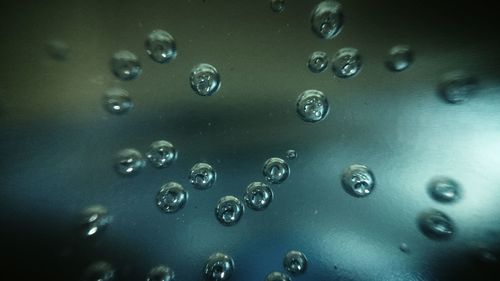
[156,182,188,213]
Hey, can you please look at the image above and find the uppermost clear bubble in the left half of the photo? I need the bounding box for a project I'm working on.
[144,29,177,63]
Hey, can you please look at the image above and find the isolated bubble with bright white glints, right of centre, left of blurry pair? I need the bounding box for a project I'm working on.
[342,164,375,197]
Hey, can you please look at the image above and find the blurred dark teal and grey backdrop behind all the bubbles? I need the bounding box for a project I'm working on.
[0,0,500,281]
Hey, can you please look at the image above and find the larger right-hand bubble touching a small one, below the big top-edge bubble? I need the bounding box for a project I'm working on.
[332,48,362,78]
